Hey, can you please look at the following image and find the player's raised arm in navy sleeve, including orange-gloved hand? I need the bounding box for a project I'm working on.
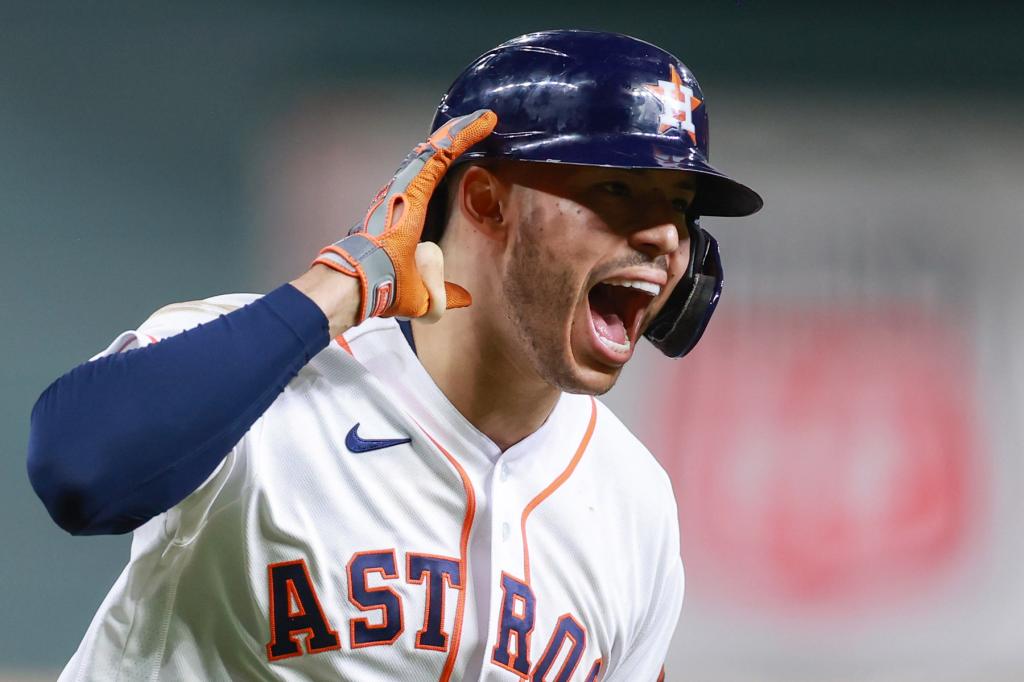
[28,111,495,535]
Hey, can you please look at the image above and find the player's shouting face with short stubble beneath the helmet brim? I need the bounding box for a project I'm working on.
[454,162,694,394]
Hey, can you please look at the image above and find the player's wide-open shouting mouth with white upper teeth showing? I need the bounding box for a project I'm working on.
[588,279,662,354]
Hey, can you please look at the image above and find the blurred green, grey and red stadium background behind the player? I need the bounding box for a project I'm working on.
[0,0,1024,682]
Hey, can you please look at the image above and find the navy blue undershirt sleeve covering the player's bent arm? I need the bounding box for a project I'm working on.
[28,285,331,535]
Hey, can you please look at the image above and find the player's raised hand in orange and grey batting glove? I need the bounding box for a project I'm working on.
[313,110,498,325]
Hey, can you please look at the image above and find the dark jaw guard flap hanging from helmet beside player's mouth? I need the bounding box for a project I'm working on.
[643,217,724,357]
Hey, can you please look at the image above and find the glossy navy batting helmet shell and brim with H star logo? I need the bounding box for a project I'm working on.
[430,31,763,216]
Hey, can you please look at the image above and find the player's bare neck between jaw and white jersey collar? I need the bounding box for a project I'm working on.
[413,310,561,451]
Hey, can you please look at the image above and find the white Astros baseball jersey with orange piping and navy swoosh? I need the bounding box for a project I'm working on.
[60,295,683,682]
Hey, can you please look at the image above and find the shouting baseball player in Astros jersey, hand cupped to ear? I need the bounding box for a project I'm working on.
[29,31,761,682]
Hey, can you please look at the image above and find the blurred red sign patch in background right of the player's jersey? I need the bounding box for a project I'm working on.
[647,308,984,613]
